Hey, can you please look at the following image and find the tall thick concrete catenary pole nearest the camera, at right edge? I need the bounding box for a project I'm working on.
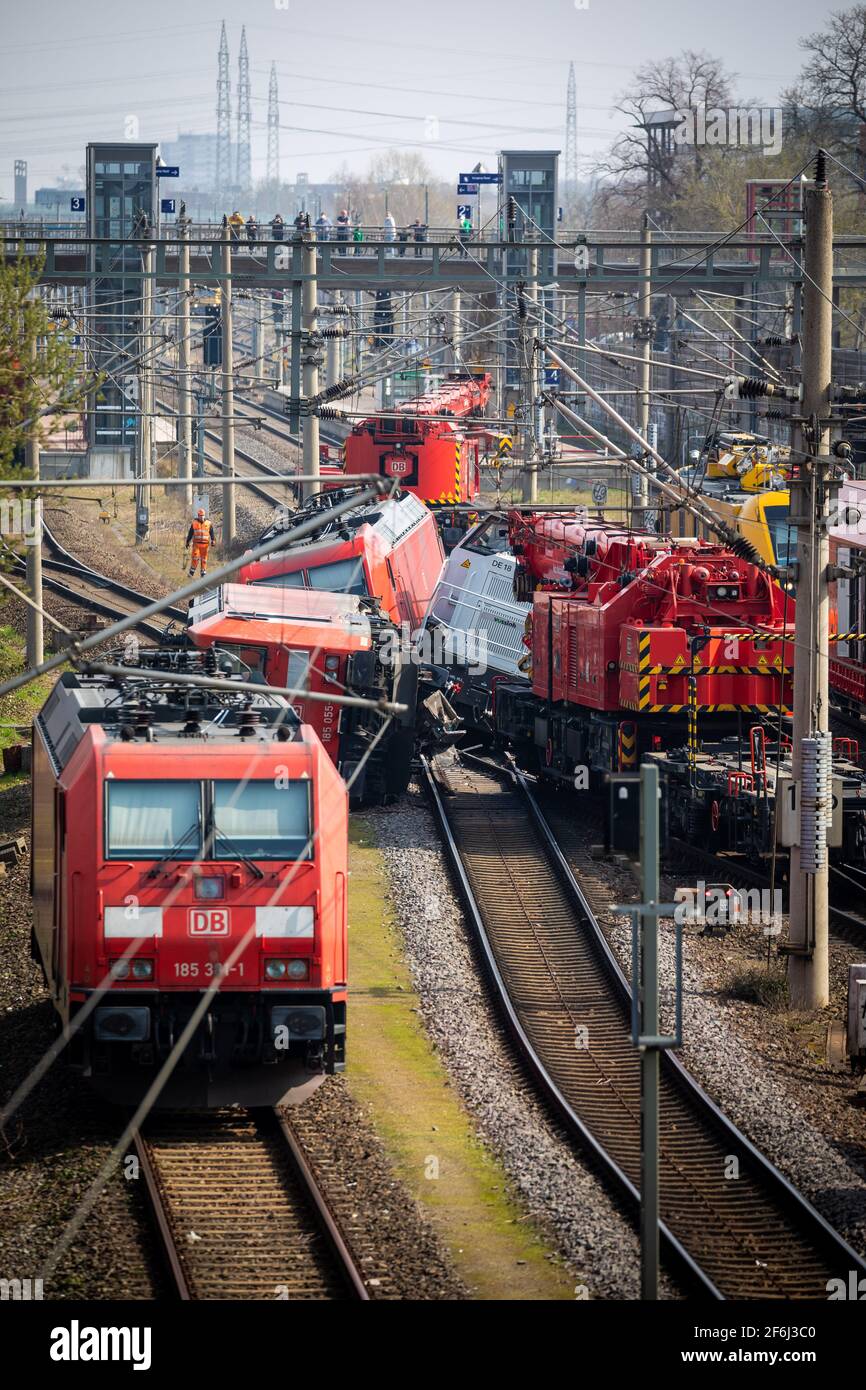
[788,152,833,1009]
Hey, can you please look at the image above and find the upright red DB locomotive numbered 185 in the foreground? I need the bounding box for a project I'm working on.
[32,649,348,1108]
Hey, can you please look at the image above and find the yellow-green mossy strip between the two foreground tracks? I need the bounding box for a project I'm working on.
[346,815,574,1300]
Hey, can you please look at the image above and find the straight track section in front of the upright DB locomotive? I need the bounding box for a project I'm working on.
[133,1109,370,1301]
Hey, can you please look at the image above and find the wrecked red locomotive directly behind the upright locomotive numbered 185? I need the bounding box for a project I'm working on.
[188,584,418,803]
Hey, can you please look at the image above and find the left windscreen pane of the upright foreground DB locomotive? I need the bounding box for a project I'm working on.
[106,780,202,859]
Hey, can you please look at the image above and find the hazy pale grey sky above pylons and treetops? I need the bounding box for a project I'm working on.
[0,0,844,197]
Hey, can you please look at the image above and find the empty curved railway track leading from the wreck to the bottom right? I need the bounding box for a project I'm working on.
[423,760,866,1298]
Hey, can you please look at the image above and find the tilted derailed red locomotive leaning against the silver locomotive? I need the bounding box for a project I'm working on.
[244,489,445,630]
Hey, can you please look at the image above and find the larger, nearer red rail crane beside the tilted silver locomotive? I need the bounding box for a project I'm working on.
[495,512,866,867]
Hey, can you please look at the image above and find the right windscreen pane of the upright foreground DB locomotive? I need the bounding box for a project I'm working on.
[213,778,310,859]
